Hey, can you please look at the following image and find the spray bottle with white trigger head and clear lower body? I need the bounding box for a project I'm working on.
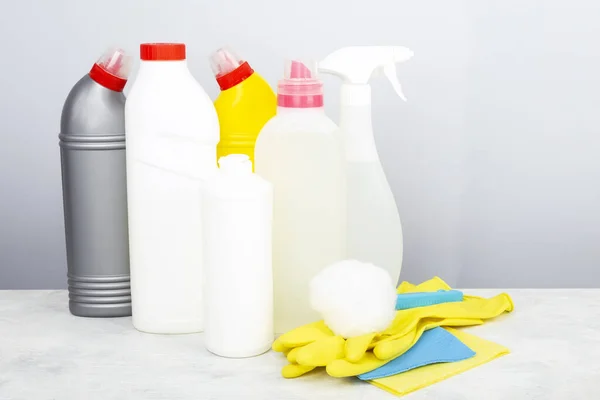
[319,46,413,282]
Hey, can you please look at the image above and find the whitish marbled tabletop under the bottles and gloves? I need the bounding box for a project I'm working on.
[0,290,600,400]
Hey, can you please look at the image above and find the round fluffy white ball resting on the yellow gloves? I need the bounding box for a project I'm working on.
[309,260,396,338]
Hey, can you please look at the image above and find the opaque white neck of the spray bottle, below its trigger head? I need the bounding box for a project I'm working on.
[340,83,379,162]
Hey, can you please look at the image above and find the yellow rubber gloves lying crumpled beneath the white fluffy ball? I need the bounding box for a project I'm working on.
[273,277,513,378]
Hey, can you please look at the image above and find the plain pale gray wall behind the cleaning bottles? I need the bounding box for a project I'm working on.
[0,0,600,289]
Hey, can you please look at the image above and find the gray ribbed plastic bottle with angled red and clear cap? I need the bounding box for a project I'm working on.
[59,49,131,317]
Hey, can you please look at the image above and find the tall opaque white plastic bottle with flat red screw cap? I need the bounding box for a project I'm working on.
[125,43,219,333]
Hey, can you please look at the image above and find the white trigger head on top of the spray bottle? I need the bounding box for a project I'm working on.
[319,46,413,101]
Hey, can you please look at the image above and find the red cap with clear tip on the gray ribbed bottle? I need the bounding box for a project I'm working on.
[90,49,131,92]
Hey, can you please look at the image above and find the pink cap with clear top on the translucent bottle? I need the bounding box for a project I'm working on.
[277,60,323,108]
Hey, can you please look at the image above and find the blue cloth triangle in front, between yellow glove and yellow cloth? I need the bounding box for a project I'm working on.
[358,327,475,381]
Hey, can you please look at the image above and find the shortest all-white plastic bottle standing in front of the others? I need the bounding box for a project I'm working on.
[203,154,273,357]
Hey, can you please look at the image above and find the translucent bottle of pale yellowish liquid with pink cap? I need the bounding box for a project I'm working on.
[255,61,346,333]
